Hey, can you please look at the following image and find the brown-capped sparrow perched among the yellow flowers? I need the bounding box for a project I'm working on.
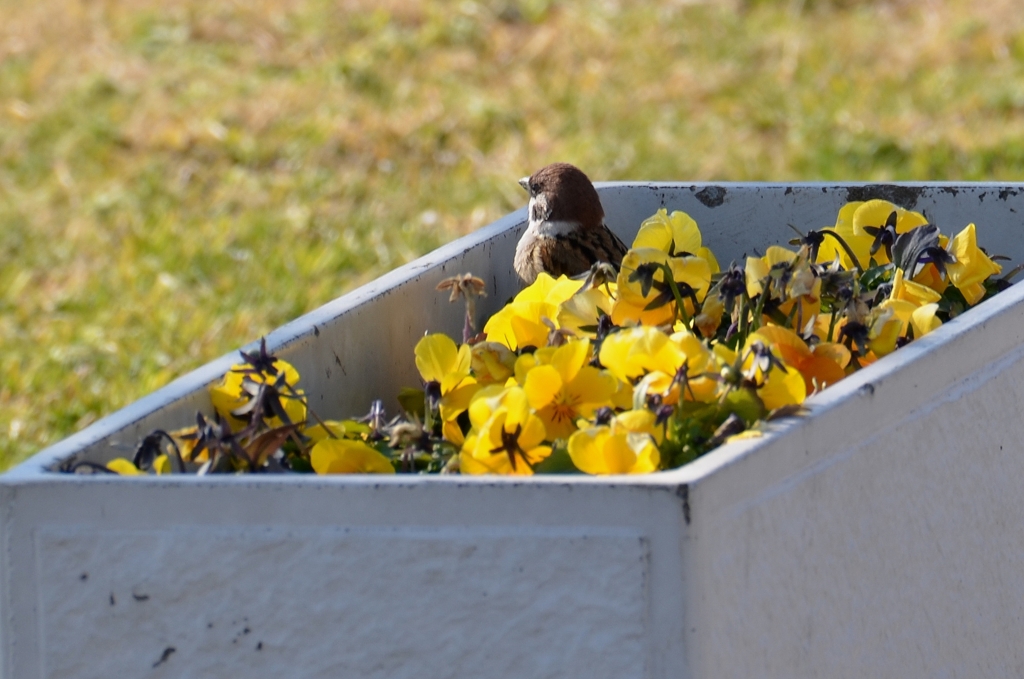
[513,163,627,285]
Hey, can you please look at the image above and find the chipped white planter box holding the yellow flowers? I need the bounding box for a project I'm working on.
[0,183,1024,679]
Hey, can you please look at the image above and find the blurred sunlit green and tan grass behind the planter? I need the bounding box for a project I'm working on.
[0,0,1024,468]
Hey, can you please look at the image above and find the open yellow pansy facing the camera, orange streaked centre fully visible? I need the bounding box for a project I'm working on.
[522,340,618,440]
